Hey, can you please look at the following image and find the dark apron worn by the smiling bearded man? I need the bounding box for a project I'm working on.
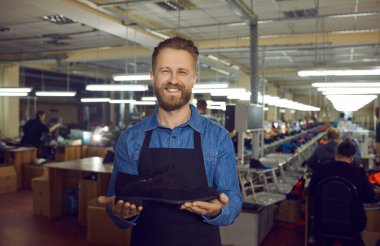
[131,130,221,246]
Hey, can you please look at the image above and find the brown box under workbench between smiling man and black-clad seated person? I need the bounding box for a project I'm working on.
[275,199,303,223]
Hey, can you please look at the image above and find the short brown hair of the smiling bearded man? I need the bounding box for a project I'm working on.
[152,37,199,70]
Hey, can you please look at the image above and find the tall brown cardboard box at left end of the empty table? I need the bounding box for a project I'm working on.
[32,176,50,217]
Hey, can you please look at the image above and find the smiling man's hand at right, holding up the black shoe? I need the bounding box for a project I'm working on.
[179,193,228,217]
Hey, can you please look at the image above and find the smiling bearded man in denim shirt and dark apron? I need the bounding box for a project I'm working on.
[98,37,242,246]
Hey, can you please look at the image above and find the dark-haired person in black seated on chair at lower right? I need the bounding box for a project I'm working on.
[308,141,375,242]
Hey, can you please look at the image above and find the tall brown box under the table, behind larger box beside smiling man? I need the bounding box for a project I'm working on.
[78,179,98,225]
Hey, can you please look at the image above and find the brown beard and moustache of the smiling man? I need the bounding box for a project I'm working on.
[154,82,191,111]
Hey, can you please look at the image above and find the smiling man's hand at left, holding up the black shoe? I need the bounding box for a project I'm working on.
[98,196,143,219]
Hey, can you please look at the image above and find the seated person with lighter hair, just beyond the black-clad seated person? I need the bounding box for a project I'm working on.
[307,128,339,171]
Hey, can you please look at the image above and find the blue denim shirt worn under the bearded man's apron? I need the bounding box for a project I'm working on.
[107,105,243,228]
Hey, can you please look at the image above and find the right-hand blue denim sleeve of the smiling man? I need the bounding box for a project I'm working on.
[203,134,243,226]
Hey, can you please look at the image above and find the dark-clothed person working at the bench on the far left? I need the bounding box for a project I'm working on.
[21,111,60,148]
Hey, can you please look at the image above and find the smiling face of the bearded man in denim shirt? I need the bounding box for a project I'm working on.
[150,48,198,111]
